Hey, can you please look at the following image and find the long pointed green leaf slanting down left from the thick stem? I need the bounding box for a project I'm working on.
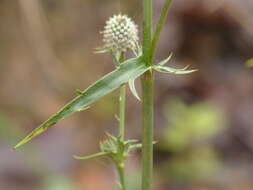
[14,57,150,149]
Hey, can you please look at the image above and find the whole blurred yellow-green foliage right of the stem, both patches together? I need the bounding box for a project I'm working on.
[158,99,226,182]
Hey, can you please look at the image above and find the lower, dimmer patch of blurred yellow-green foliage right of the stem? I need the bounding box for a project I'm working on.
[162,147,221,182]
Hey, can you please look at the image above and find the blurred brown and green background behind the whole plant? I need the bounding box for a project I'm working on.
[0,0,253,190]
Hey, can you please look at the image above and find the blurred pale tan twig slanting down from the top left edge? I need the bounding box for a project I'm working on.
[18,0,73,94]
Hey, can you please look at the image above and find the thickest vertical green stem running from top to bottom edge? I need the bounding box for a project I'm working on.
[141,0,154,190]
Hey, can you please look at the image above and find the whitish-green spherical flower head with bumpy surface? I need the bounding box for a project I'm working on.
[102,14,138,53]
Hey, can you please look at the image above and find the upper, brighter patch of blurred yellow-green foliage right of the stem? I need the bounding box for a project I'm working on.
[163,99,224,152]
